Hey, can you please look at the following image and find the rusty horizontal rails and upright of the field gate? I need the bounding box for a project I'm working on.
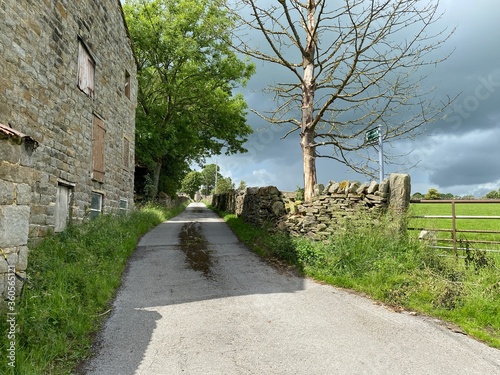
[408,199,500,255]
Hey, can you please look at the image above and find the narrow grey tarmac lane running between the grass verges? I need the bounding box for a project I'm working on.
[83,204,500,375]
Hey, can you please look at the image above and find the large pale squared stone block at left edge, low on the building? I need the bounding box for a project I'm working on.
[0,206,30,247]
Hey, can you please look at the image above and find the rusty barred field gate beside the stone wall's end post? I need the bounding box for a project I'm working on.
[408,199,500,255]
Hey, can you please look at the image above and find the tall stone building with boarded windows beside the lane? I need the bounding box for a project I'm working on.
[0,0,137,295]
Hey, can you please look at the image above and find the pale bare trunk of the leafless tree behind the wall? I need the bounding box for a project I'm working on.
[300,0,317,202]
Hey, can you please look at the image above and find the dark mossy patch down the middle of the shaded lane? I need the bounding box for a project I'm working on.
[179,223,215,278]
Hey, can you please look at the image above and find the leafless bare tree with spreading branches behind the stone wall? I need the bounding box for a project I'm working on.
[231,0,453,200]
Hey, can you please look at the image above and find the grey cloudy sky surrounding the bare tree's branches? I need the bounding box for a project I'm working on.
[204,0,500,197]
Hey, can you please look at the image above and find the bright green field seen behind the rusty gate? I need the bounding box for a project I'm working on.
[408,201,500,252]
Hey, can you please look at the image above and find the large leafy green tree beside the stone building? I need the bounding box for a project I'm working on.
[123,0,254,197]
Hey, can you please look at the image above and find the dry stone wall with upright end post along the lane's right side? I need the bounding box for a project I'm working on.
[212,174,410,239]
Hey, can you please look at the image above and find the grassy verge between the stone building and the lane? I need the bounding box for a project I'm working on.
[0,205,185,375]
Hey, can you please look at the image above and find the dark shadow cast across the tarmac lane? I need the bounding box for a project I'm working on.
[79,204,304,375]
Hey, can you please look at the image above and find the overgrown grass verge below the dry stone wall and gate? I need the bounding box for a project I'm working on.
[213,212,500,348]
